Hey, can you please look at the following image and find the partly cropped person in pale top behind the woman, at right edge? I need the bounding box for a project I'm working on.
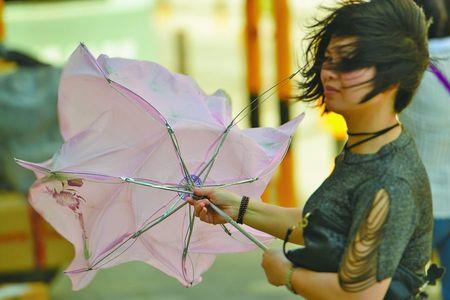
[400,0,450,300]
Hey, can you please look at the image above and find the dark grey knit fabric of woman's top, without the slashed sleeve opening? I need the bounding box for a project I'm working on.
[303,129,433,281]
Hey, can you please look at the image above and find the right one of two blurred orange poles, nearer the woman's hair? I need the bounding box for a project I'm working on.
[273,0,297,207]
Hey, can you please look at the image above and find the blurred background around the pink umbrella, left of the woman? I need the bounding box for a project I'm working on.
[0,0,439,300]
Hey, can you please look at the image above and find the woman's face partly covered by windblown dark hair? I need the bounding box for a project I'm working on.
[320,38,376,115]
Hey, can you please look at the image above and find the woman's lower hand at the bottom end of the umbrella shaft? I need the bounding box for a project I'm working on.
[261,250,292,286]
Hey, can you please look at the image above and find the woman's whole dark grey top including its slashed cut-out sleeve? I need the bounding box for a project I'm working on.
[303,129,433,291]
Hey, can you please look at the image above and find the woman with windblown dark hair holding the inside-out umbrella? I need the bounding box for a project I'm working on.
[189,0,433,299]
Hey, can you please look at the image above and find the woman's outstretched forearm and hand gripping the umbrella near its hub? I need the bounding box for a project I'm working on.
[187,188,303,244]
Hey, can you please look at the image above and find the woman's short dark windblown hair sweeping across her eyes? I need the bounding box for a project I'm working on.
[297,0,430,113]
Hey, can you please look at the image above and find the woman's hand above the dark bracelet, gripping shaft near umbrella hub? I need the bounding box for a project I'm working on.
[186,188,241,224]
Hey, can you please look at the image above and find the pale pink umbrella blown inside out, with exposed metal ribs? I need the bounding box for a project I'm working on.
[16,45,304,290]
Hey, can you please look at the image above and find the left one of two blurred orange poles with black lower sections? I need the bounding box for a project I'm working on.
[245,0,261,127]
